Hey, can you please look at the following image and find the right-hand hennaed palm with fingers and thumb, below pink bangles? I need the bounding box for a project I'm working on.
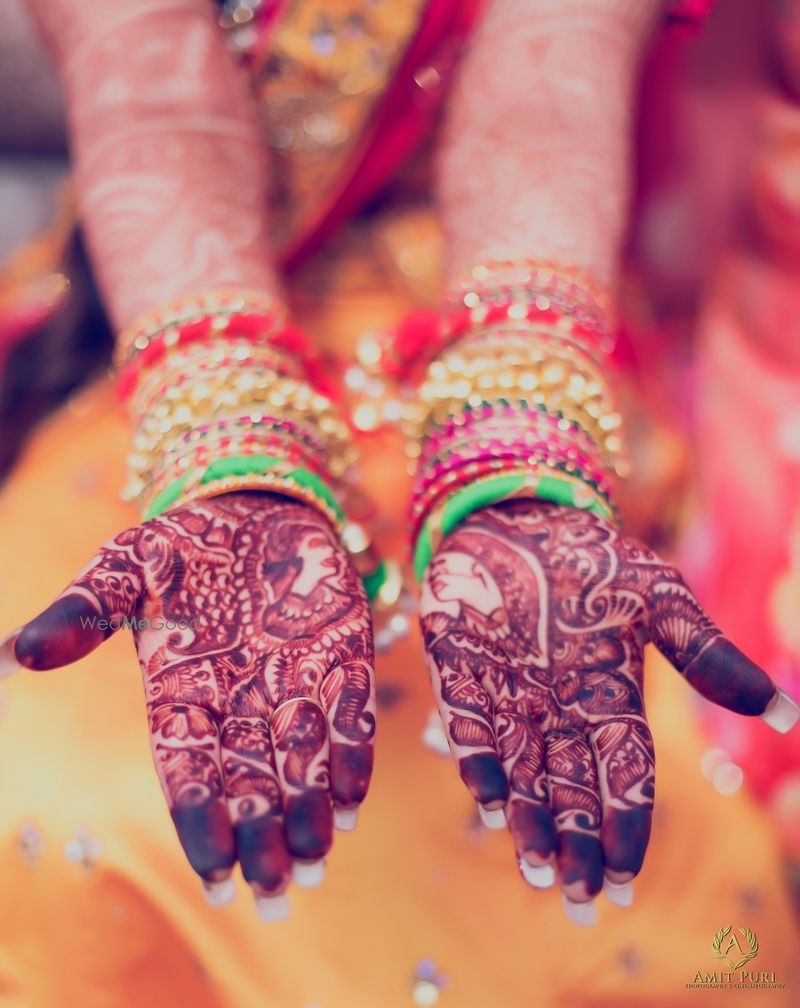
[421,500,798,922]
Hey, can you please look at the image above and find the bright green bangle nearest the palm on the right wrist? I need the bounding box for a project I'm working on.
[413,467,614,583]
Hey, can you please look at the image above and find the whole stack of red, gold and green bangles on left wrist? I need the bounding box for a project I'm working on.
[117,287,399,604]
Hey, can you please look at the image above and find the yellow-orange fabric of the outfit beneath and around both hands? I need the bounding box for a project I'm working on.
[0,224,800,1008]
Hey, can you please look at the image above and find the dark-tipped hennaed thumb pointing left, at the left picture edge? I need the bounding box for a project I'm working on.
[0,531,143,678]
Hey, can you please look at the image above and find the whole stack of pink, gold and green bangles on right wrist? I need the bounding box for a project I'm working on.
[394,262,626,581]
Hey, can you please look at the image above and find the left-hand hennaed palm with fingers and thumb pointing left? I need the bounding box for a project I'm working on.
[3,493,375,916]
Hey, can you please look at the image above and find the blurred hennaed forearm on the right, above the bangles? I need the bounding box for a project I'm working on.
[438,0,662,284]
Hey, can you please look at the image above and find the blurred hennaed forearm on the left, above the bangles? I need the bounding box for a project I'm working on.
[28,0,276,329]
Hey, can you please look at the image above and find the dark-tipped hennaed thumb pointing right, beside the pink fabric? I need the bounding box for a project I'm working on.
[649,568,800,732]
